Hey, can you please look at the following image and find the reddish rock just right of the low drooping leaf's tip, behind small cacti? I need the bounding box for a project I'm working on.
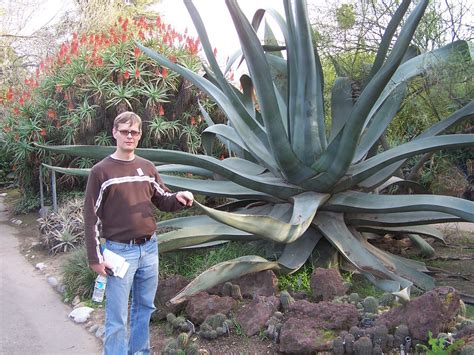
[186,292,236,325]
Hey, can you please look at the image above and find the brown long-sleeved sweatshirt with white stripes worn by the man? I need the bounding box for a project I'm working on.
[84,156,183,264]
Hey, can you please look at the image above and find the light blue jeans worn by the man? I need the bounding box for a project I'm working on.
[104,235,158,355]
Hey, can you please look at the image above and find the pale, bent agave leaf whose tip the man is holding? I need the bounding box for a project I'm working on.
[196,192,329,243]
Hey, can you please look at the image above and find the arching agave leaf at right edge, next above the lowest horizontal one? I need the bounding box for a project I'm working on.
[334,134,474,192]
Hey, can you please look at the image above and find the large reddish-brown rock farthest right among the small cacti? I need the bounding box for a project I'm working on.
[376,286,460,341]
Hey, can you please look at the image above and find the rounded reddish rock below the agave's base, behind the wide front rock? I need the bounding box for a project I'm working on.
[310,268,347,301]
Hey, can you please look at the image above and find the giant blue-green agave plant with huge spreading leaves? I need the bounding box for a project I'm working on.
[41,0,474,302]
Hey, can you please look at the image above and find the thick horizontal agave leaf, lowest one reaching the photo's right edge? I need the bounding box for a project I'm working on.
[324,191,474,224]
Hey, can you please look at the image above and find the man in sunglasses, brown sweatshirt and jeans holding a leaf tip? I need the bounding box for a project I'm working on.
[84,112,194,355]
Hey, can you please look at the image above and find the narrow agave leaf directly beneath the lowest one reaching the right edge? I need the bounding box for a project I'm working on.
[344,211,461,226]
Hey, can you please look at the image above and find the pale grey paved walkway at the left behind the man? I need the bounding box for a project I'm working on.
[0,197,101,355]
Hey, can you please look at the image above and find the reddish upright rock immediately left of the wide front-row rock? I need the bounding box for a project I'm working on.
[236,296,280,336]
